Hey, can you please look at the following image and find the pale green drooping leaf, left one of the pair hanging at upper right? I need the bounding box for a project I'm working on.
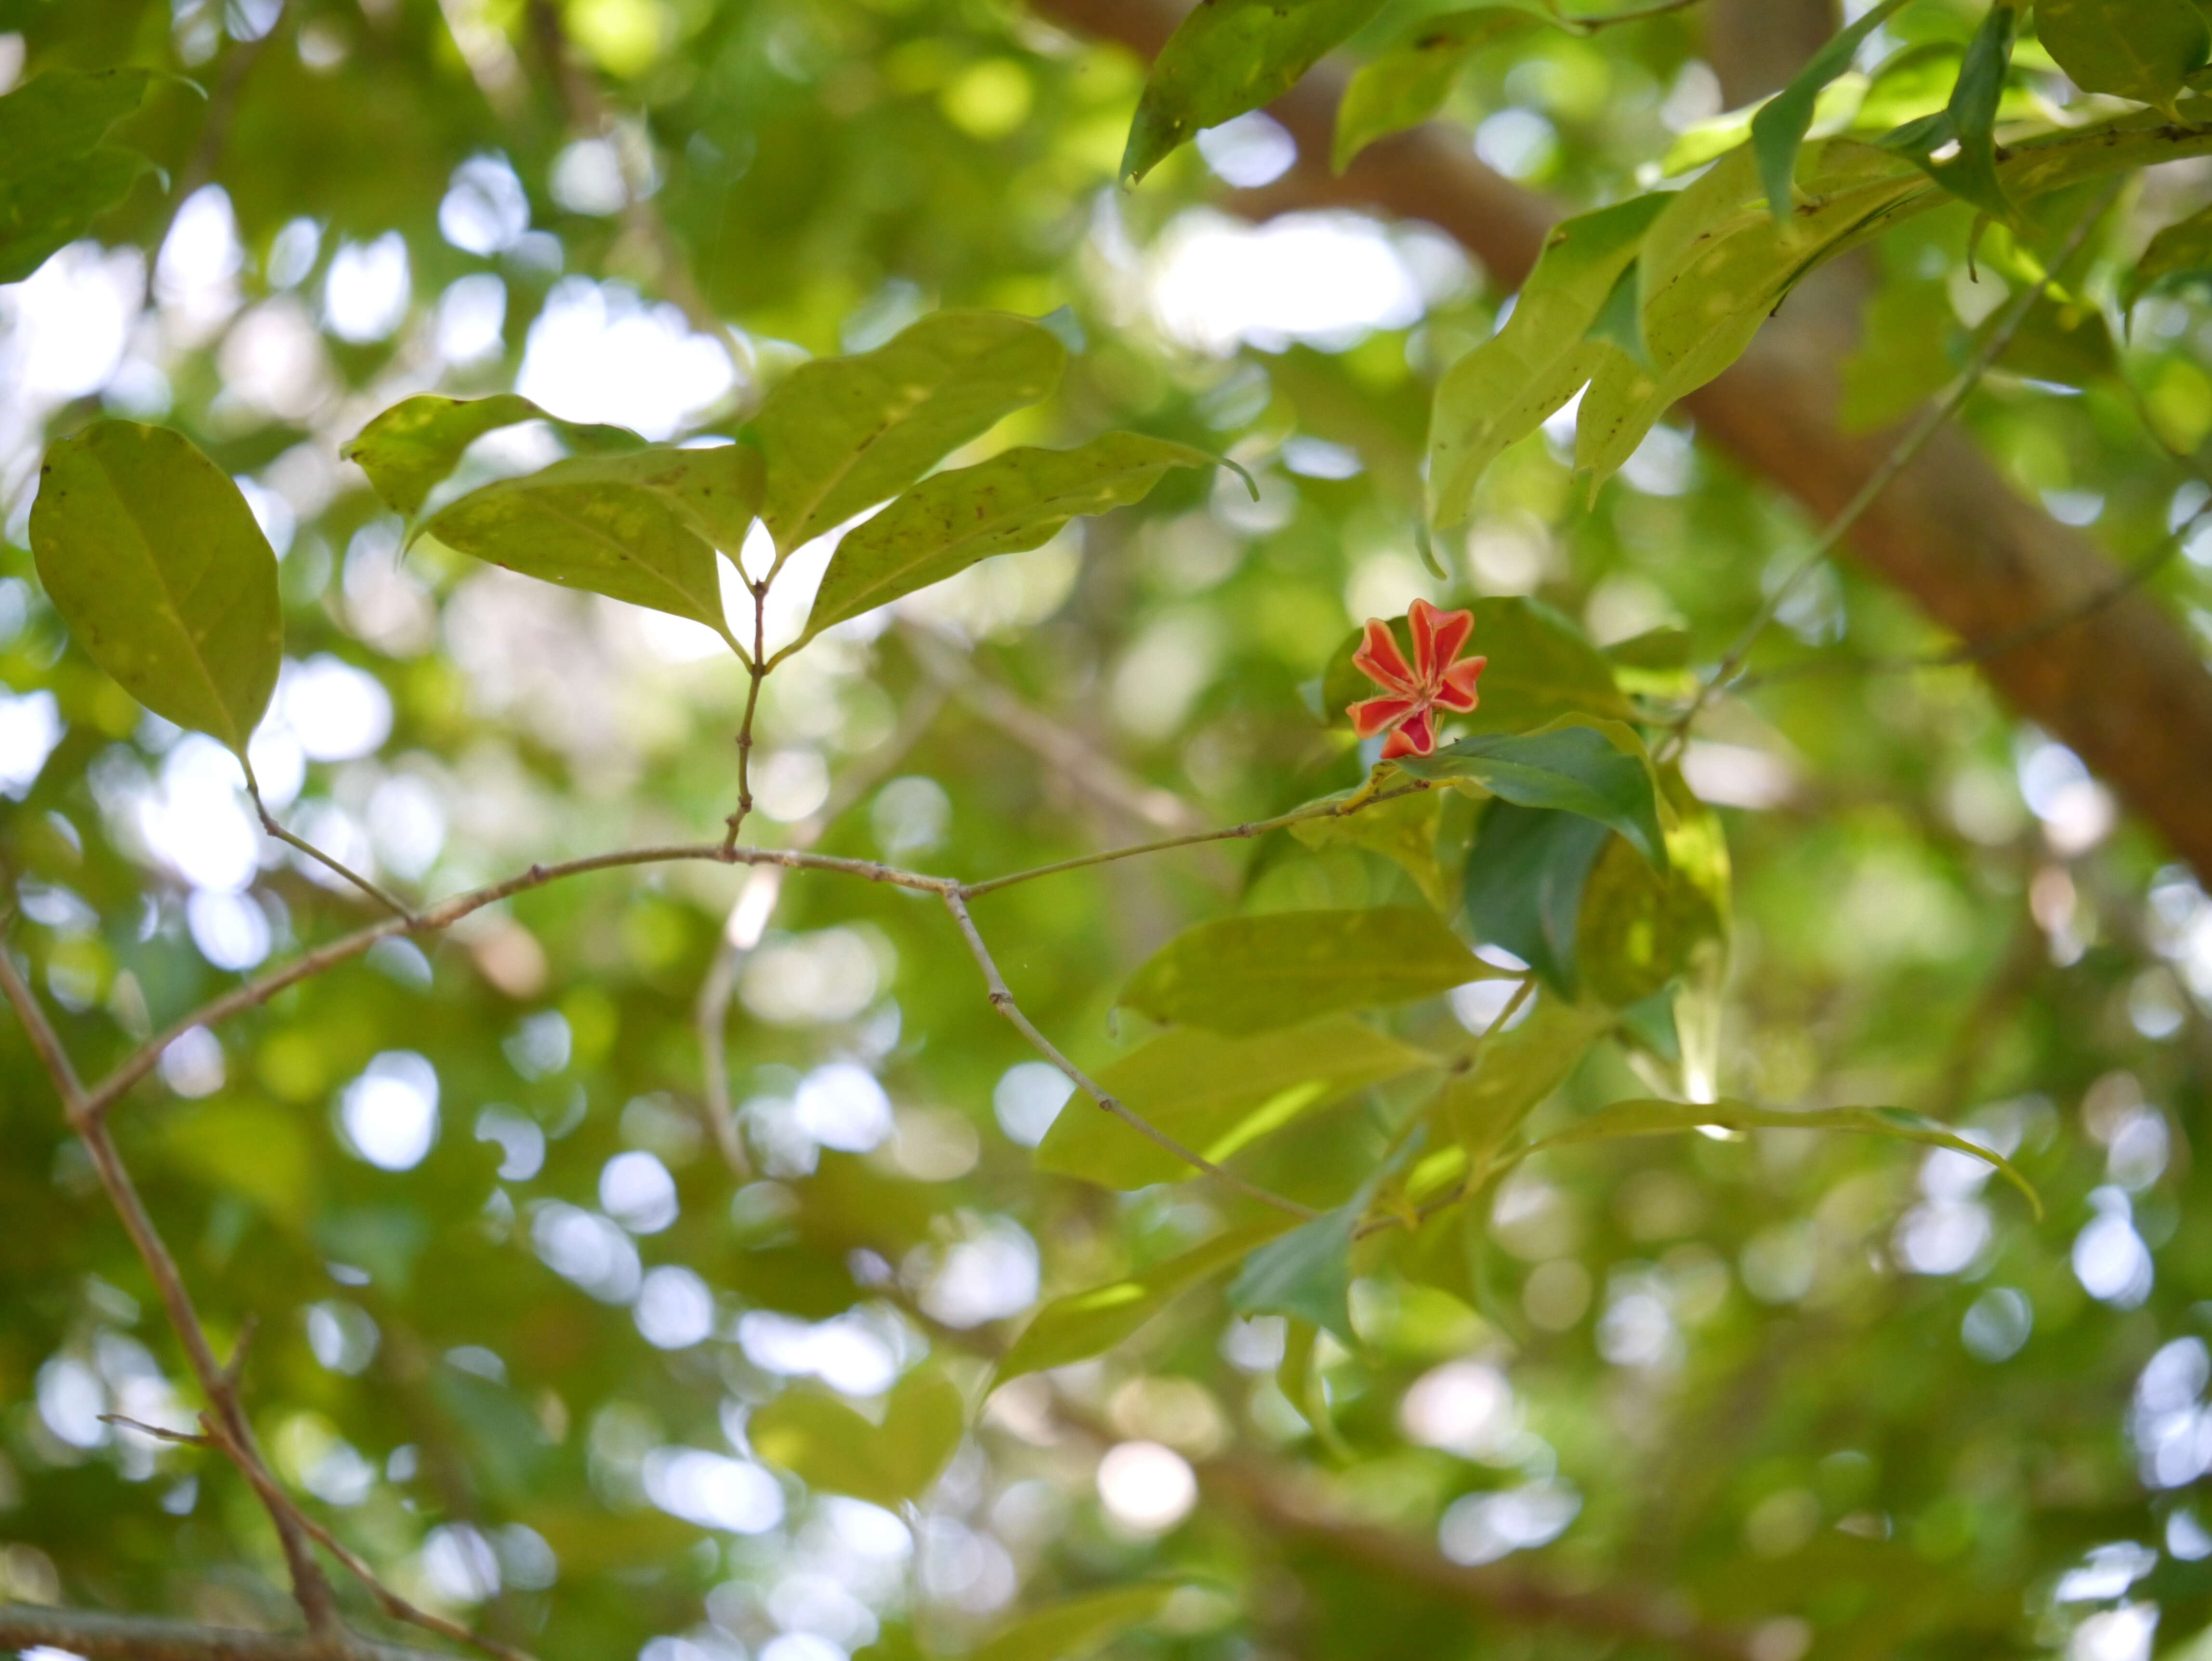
[1429,195,1672,528]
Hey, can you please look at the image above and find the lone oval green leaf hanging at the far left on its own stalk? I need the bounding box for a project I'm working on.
[31,420,283,761]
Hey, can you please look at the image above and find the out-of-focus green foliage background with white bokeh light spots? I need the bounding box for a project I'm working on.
[0,0,2212,1661]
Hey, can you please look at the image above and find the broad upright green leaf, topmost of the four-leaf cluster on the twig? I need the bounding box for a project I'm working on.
[750,312,1068,555]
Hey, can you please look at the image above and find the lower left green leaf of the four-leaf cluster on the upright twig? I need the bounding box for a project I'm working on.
[422,445,761,650]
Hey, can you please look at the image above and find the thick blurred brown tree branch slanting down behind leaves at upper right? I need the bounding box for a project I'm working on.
[1033,0,2212,878]
